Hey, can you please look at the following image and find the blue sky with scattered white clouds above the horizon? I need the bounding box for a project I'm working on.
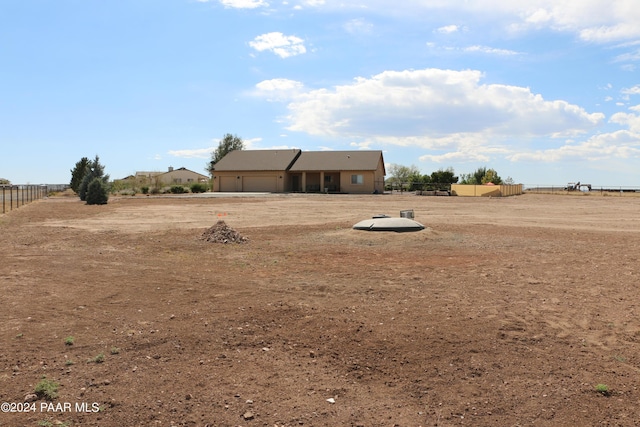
[0,0,640,186]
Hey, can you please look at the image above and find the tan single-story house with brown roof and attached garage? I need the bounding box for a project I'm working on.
[213,149,385,194]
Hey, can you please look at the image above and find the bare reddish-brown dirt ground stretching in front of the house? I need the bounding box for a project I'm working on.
[0,194,640,427]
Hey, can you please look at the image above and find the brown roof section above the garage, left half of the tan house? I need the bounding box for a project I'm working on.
[214,149,300,172]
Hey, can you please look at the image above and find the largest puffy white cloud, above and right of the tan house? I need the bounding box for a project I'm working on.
[288,69,604,149]
